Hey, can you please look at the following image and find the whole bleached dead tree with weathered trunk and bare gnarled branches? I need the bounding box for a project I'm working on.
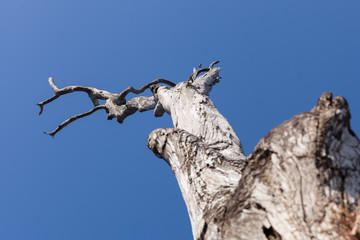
[38,62,360,240]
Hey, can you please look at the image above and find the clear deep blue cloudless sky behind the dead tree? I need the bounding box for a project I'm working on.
[0,0,360,240]
